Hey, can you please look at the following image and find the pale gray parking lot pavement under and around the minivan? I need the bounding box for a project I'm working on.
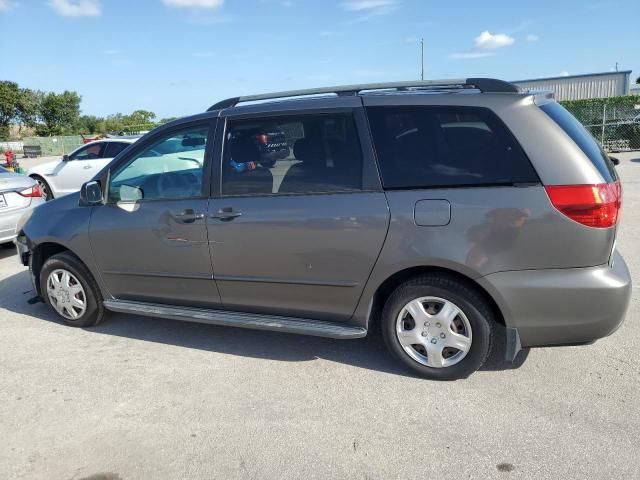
[0,153,640,480]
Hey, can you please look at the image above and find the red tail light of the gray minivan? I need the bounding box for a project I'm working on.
[545,182,622,228]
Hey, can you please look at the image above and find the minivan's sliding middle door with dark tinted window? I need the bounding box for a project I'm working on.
[209,107,389,321]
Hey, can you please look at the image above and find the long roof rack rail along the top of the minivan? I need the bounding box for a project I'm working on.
[207,78,519,112]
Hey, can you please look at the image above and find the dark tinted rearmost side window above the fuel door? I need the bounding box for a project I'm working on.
[367,106,539,189]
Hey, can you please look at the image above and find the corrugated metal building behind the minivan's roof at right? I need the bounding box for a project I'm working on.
[511,70,631,100]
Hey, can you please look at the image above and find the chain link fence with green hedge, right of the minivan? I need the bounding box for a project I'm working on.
[561,96,640,152]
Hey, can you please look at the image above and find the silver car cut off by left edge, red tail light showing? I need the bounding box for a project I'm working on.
[0,167,44,247]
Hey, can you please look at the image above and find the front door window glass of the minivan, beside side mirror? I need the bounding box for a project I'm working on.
[109,125,208,202]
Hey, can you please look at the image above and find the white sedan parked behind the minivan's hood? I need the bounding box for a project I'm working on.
[27,137,139,200]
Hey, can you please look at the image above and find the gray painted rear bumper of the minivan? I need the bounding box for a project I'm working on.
[480,251,631,347]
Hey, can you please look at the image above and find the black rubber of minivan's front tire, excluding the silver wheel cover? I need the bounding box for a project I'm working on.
[40,252,106,327]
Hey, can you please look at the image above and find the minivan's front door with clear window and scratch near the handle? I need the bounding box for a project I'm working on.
[90,121,220,306]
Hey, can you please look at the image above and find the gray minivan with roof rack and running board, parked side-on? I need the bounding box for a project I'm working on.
[18,79,631,380]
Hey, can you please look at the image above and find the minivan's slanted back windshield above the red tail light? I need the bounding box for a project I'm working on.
[540,102,618,183]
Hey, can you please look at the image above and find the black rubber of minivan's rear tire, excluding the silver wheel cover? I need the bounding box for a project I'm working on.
[381,273,497,380]
